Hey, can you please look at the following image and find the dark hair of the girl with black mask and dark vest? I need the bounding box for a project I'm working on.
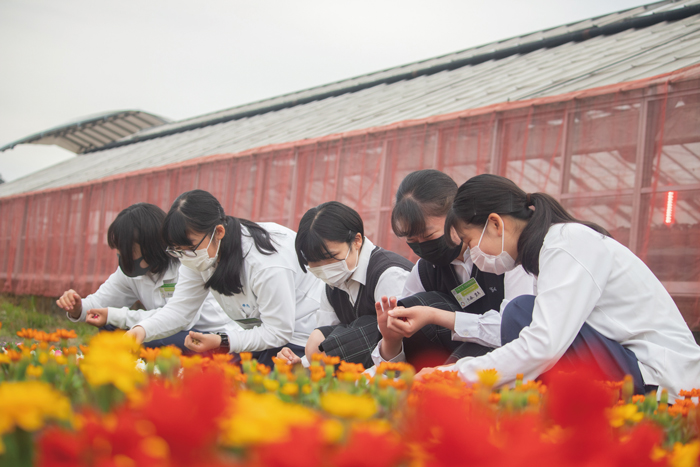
[391,169,457,237]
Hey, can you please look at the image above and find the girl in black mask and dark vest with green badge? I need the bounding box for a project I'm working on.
[372,169,534,370]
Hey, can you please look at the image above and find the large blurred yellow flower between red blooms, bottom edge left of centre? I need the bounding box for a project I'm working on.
[221,391,318,446]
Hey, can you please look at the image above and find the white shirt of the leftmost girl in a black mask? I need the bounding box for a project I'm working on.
[66,262,231,332]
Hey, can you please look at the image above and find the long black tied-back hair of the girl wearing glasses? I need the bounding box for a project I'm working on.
[163,190,277,295]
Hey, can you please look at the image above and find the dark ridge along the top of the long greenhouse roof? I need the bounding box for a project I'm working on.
[85,2,700,153]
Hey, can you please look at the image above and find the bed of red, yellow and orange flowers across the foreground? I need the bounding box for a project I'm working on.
[0,330,700,467]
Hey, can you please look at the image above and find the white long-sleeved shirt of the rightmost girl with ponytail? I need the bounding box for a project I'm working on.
[448,224,700,400]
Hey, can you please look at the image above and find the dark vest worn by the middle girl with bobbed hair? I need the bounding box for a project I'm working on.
[326,247,413,324]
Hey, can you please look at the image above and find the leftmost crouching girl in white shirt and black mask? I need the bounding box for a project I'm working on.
[56,203,235,350]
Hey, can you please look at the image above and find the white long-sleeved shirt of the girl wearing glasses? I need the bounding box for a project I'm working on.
[139,223,324,352]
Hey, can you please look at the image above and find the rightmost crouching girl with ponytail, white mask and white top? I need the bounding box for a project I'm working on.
[410,175,700,400]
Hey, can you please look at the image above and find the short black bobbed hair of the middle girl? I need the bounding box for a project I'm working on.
[294,201,365,272]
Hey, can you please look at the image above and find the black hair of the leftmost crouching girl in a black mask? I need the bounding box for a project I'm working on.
[107,203,177,276]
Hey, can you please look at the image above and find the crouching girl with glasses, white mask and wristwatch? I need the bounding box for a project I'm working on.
[129,190,323,364]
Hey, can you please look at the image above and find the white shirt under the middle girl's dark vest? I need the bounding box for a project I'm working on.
[316,237,410,328]
